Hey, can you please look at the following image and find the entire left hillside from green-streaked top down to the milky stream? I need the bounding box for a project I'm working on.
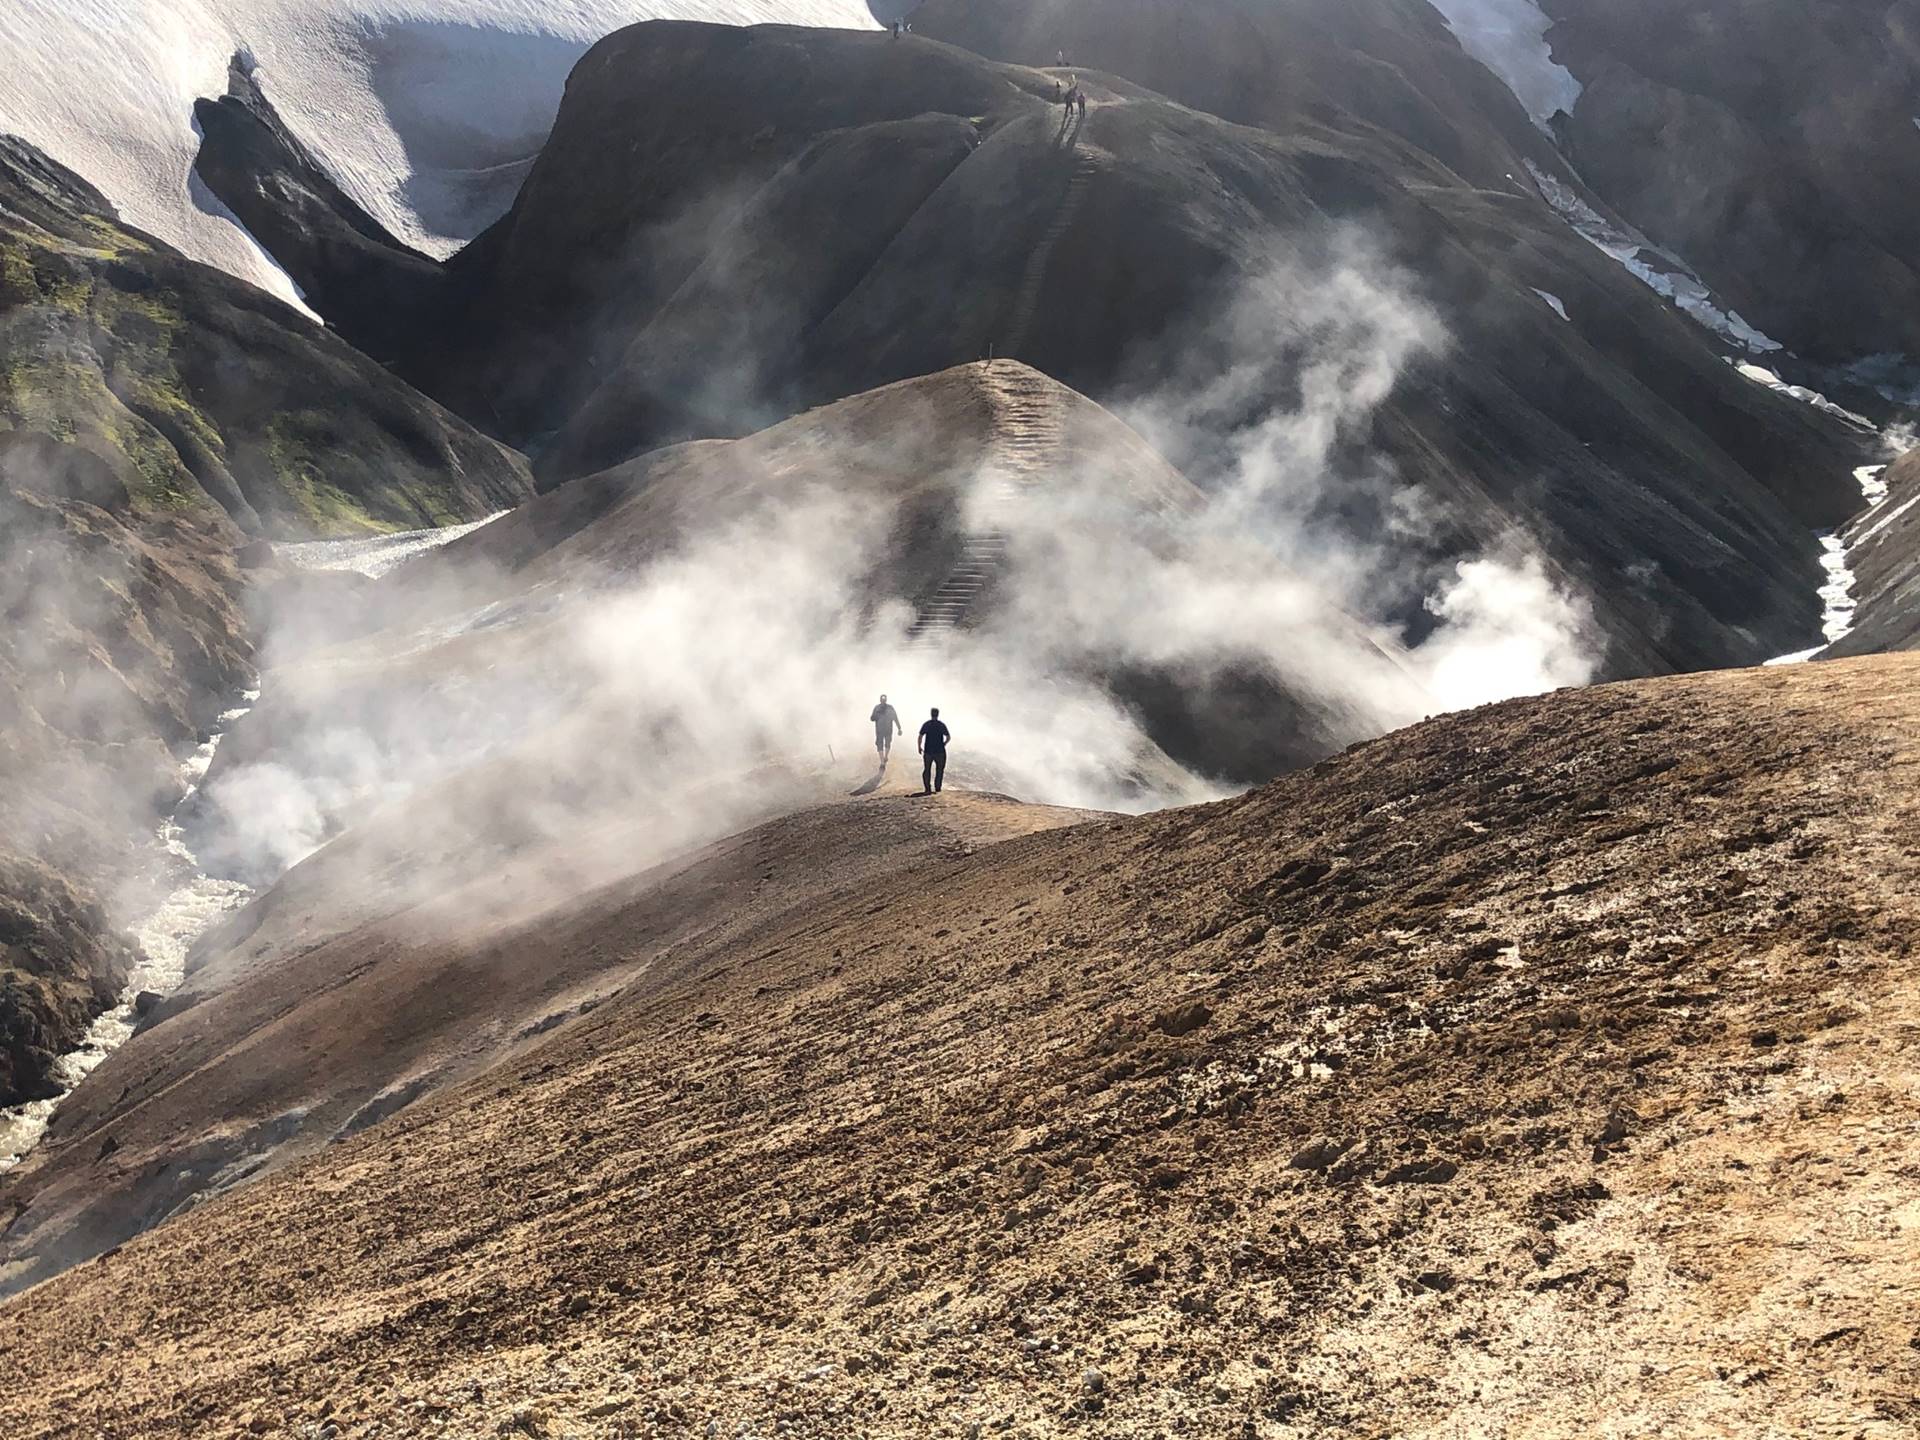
[0,140,530,1106]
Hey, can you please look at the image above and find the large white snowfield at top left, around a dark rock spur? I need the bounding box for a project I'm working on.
[0,0,874,301]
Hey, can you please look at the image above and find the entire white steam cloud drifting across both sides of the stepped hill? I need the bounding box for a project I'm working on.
[187,236,1594,913]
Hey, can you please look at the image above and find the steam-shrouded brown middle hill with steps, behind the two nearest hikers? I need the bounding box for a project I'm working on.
[0,361,1432,1284]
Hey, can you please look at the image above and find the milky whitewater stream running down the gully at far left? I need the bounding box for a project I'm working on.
[0,691,259,1173]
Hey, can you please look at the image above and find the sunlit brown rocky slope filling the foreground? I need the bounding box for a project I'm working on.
[0,657,1920,1436]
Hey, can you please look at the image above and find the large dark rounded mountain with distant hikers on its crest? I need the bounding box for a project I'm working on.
[204,15,1860,674]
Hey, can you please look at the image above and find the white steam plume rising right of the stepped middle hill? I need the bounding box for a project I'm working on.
[989,232,1596,743]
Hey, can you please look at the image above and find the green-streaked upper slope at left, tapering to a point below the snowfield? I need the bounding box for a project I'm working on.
[0,140,528,538]
